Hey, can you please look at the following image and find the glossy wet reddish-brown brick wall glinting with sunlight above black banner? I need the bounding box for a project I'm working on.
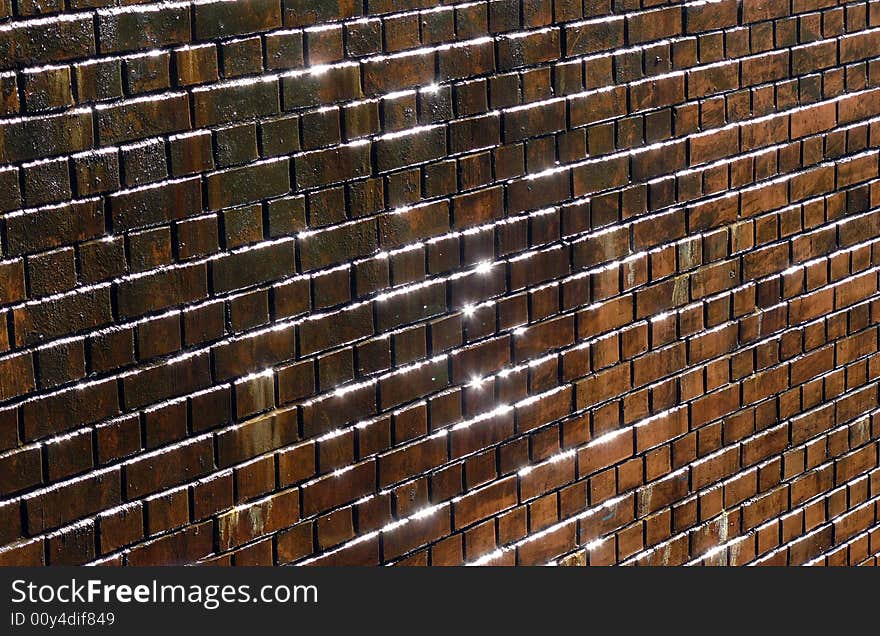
[0,0,880,565]
